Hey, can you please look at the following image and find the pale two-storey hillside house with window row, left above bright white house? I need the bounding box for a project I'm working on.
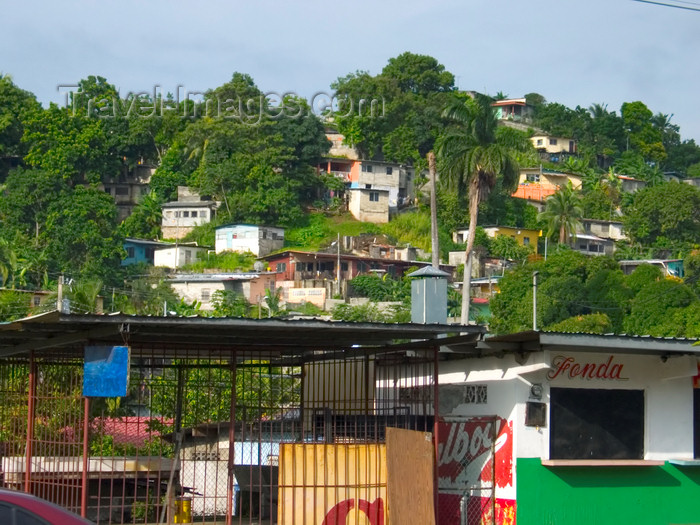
[161,186,218,239]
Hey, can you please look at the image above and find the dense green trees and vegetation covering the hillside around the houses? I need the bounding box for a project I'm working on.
[0,53,700,333]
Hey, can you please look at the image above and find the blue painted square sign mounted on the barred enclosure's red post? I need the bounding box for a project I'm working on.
[83,346,129,397]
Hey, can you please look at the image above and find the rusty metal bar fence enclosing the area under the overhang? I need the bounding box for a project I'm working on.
[0,347,437,525]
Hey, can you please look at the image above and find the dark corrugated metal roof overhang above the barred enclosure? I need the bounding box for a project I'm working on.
[0,312,485,362]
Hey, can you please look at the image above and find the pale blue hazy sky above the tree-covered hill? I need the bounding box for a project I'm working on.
[0,0,700,139]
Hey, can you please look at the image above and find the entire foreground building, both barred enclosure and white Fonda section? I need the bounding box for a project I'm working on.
[0,313,700,525]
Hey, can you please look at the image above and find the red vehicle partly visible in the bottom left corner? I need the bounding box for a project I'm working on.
[0,489,94,525]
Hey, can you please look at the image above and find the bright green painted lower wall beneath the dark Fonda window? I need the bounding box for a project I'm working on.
[516,458,700,525]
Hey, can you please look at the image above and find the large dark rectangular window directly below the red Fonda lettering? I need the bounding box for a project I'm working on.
[549,388,644,459]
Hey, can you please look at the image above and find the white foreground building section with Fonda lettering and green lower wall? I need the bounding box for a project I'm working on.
[426,332,700,524]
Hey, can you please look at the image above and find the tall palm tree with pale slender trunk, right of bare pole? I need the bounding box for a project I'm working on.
[438,95,529,324]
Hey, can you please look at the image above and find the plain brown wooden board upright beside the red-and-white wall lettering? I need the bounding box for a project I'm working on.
[386,427,435,525]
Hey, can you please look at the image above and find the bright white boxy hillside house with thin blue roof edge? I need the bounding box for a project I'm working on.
[215,224,284,257]
